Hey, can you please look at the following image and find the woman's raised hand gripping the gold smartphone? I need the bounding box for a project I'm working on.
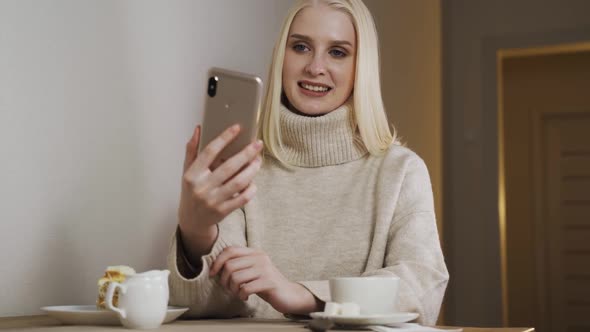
[178,125,262,262]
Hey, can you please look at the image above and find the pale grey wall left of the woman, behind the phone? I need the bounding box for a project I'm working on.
[0,0,291,316]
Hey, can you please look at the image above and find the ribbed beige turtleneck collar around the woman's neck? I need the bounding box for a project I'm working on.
[280,102,367,167]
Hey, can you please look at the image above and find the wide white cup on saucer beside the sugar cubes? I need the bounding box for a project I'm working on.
[329,277,399,315]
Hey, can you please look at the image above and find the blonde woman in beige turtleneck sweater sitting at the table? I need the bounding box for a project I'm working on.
[169,0,448,325]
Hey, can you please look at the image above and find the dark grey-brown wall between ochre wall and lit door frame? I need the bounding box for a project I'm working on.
[442,0,590,326]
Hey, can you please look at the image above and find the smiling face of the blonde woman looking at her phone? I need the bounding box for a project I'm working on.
[283,5,356,115]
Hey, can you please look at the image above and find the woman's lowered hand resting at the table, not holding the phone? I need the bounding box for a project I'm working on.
[209,247,319,314]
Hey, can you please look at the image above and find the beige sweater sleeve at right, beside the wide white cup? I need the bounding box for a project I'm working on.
[363,158,449,325]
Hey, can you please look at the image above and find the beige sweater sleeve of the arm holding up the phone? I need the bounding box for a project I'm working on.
[167,209,254,318]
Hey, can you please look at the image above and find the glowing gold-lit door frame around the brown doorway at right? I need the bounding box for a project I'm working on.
[490,31,590,326]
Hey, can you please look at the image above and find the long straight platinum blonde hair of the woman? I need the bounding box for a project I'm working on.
[258,0,396,165]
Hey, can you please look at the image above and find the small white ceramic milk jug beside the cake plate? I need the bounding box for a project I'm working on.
[105,270,170,330]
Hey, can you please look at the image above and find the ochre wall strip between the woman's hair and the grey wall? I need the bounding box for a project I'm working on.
[365,0,443,233]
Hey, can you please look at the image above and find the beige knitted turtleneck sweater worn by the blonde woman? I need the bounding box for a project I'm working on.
[168,105,449,325]
